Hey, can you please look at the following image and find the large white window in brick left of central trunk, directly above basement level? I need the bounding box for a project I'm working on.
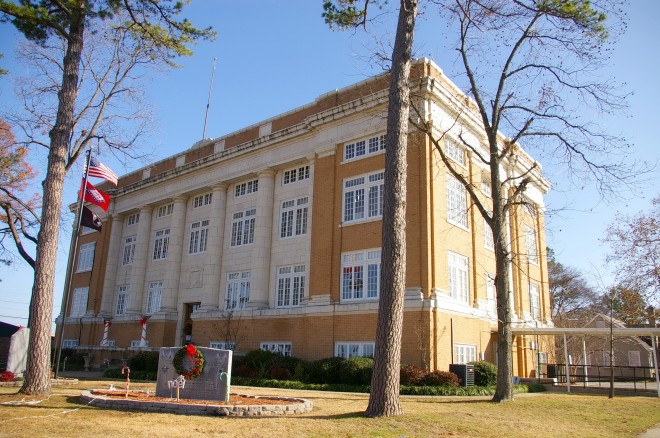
[341,249,380,301]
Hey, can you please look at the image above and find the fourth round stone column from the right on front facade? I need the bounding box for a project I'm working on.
[126,205,153,316]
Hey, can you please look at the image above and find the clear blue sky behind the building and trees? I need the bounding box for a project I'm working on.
[0,0,660,324]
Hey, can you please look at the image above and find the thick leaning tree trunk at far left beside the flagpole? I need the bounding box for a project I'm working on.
[20,14,85,395]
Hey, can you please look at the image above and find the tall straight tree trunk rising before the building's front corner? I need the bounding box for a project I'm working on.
[365,0,417,417]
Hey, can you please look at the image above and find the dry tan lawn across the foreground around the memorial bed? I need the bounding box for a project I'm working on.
[0,381,660,438]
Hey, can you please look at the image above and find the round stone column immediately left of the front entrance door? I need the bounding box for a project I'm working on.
[160,196,188,313]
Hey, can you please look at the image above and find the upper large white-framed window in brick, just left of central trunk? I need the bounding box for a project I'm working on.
[344,172,385,222]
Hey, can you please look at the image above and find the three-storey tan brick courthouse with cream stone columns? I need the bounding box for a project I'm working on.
[57,59,552,376]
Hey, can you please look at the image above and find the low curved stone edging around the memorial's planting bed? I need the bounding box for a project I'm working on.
[80,390,312,417]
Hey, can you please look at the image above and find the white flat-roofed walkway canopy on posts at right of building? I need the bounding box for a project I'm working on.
[511,327,660,397]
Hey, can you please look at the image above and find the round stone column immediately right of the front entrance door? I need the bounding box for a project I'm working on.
[202,183,228,312]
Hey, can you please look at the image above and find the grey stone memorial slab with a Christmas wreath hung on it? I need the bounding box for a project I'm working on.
[156,347,232,401]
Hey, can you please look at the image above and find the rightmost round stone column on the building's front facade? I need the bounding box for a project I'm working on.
[248,169,275,308]
